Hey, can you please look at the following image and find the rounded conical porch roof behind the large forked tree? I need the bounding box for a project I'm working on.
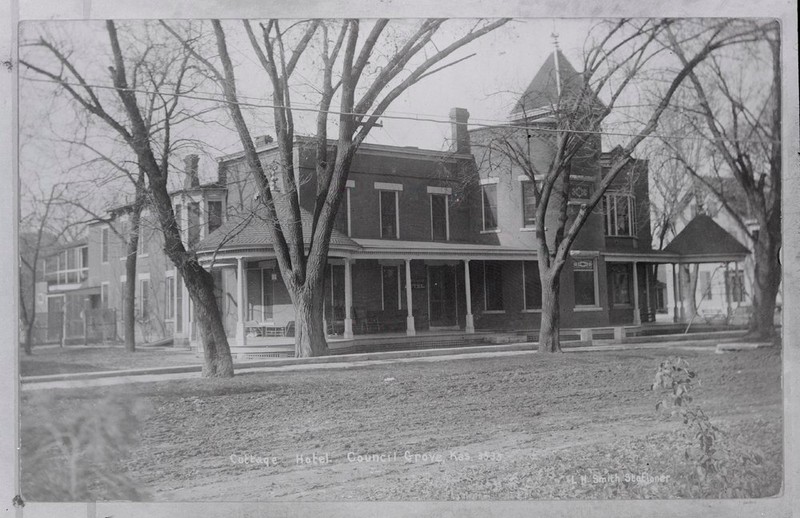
[197,208,358,252]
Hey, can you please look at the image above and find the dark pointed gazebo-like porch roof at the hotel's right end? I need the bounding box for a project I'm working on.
[664,214,750,256]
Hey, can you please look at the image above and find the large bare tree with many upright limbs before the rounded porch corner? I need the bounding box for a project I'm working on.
[165,19,508,357]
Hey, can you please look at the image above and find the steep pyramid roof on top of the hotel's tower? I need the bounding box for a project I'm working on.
[511,50,602,116]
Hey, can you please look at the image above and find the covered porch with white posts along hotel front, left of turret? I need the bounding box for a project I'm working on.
[195,239,535,350]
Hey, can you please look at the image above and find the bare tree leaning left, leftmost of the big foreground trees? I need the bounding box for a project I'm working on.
[21,20,233,377]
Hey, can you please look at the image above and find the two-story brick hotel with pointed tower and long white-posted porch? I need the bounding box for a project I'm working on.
[28,52,744,351]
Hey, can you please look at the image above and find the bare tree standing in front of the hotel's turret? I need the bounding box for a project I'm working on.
[472,19,754,352]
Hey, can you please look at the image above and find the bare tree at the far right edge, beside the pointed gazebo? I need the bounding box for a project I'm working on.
[670,21,782,339]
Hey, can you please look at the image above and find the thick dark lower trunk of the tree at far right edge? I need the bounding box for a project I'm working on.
[748,232,781,340]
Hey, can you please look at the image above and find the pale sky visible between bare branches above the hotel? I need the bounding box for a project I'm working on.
[14,18,776,224]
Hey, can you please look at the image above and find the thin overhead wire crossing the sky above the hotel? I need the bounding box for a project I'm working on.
[25,78,779,143]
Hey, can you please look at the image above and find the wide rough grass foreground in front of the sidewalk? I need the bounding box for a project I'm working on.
[21,349,783,501]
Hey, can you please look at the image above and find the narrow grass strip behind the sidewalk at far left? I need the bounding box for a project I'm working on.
[19,346,203,376]
